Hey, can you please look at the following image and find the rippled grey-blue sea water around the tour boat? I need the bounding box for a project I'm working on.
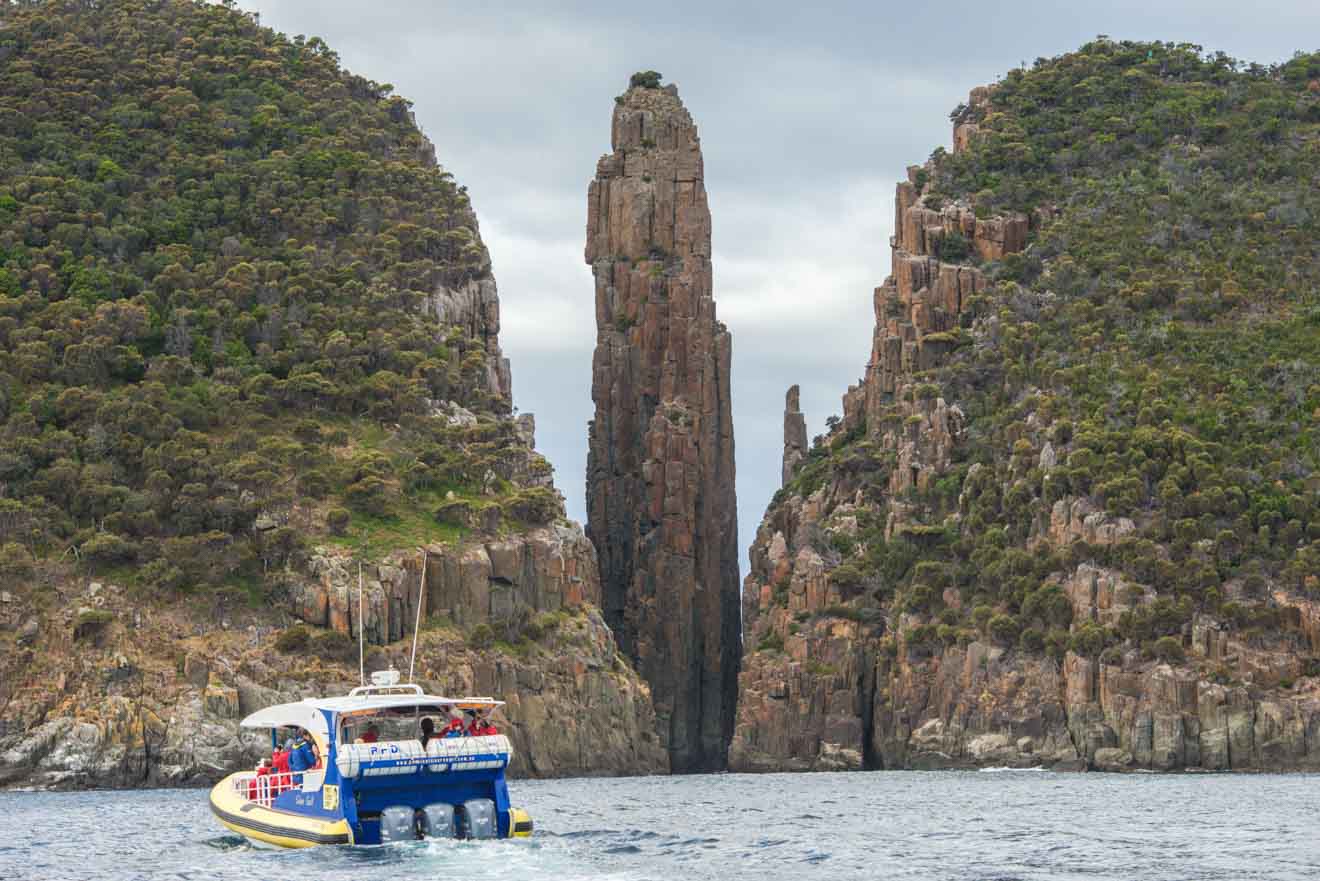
[0,771,1320,881]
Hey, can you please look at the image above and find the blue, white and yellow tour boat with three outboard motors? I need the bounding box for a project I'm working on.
[211,670,532,848]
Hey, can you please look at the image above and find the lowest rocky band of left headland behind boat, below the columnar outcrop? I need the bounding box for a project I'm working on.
[0,581,668,789]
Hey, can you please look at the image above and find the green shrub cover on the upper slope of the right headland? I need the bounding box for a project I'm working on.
[787,40,1320,656]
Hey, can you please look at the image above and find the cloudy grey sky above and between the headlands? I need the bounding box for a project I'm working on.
[239,0,1320,573]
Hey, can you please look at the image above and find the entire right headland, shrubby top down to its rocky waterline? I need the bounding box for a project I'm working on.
[733,37,1320,769]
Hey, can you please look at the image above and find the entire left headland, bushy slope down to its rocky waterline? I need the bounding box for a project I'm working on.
[0,0,668,787]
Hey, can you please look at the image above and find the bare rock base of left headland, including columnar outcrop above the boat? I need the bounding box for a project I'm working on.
[0,293,669,789]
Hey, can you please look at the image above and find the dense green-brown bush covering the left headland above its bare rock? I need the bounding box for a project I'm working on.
[0,0,561,594]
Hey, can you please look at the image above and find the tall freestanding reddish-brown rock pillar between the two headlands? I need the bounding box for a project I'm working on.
[586,80,739,771]
